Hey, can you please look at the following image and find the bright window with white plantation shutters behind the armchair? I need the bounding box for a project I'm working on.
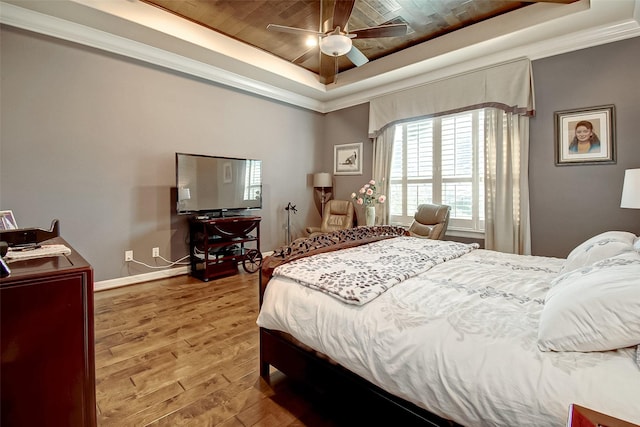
[389,110,484,232]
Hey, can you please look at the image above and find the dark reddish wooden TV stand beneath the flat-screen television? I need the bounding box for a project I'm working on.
[189,216,262,282]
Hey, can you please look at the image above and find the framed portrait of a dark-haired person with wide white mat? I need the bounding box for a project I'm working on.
[554,105,615,166]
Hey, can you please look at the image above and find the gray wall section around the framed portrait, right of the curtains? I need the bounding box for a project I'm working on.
[529,37,640,257]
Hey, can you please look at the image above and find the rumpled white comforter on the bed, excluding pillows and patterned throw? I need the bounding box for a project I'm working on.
[258,244,640,426]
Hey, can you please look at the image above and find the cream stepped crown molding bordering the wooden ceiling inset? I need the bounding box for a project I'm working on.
[0,0,640,113]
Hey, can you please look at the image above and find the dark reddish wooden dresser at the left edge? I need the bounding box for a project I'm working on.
[0,237,96,427]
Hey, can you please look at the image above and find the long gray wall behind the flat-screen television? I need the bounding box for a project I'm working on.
[0,27,324,281]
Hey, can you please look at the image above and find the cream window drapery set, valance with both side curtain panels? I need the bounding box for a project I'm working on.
[369,58,535,254]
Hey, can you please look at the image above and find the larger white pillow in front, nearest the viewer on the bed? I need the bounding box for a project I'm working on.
[538,251,640,351]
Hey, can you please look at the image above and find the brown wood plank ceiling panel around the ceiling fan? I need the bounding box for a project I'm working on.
[143,0,578,83]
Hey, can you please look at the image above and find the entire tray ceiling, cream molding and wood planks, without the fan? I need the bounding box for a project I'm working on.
[0,0,640,112]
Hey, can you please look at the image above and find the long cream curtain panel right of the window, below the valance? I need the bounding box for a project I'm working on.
[484,108,531,255]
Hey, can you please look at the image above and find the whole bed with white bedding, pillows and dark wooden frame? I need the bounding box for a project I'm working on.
[257,226,640,426]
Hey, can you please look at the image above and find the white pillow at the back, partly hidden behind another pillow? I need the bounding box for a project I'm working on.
[560,231,636,273]
